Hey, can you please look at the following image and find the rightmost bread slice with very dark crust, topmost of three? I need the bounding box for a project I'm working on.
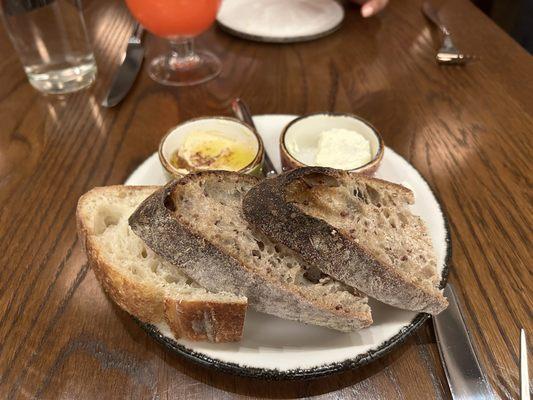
[243,167,448,314]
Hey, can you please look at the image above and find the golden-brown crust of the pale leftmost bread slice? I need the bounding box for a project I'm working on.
[76,186,247,342]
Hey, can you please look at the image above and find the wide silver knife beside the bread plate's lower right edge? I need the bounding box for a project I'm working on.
[433,283,494,400]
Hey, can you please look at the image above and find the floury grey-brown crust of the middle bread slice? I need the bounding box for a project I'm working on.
[129,171,372,331]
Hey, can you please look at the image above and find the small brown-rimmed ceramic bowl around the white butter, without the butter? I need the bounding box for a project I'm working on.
[279,113,385,175]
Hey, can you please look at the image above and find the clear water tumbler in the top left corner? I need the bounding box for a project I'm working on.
[0,0,96,93]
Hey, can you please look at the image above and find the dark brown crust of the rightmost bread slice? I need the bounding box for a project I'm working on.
[243,167,448,314]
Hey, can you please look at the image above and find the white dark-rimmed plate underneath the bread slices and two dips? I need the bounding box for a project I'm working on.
[126,115,450,379]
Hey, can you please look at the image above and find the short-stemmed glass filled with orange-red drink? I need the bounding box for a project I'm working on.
[126,0,221,86]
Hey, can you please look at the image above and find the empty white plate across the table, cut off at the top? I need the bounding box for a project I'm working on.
[217,0,344,43]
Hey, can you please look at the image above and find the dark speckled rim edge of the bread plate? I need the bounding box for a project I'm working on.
[136,154,452,380]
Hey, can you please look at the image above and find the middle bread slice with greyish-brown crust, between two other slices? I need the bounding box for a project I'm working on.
[130,171,372,331]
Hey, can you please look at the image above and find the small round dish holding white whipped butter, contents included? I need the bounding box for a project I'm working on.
[280,113,385,175]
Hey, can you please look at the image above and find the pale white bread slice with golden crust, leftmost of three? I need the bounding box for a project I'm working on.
[77,186,247,342]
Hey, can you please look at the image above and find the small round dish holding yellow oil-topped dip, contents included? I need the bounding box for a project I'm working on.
[159,117,264,179]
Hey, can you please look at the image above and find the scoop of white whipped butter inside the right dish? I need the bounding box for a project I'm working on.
[314,129,372,169]
